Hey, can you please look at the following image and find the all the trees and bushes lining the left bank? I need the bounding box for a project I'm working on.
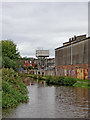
[1,40,28,108]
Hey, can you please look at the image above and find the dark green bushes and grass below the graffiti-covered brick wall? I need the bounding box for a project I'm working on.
[46,76,90,88]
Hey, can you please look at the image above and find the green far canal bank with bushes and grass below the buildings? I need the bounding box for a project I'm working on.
[21,74,90,88]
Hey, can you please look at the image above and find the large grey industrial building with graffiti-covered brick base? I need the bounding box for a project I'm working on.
[55,35,90,79]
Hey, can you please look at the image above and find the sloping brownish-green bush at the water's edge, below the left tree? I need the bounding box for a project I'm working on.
[2,68,28,108]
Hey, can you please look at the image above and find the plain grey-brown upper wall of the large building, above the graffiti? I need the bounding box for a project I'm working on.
[55,39,89,66]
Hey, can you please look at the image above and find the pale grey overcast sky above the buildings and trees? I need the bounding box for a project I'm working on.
[2,2,88,57]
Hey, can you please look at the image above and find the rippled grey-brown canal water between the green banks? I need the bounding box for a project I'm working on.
[2,78,89,118]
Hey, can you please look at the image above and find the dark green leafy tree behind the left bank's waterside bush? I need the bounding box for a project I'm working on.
[1,40,20,71]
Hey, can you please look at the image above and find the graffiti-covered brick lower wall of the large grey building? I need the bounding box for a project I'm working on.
[56,64,90,80]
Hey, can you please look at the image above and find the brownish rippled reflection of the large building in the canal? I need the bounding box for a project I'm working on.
[55,86,88,118]
